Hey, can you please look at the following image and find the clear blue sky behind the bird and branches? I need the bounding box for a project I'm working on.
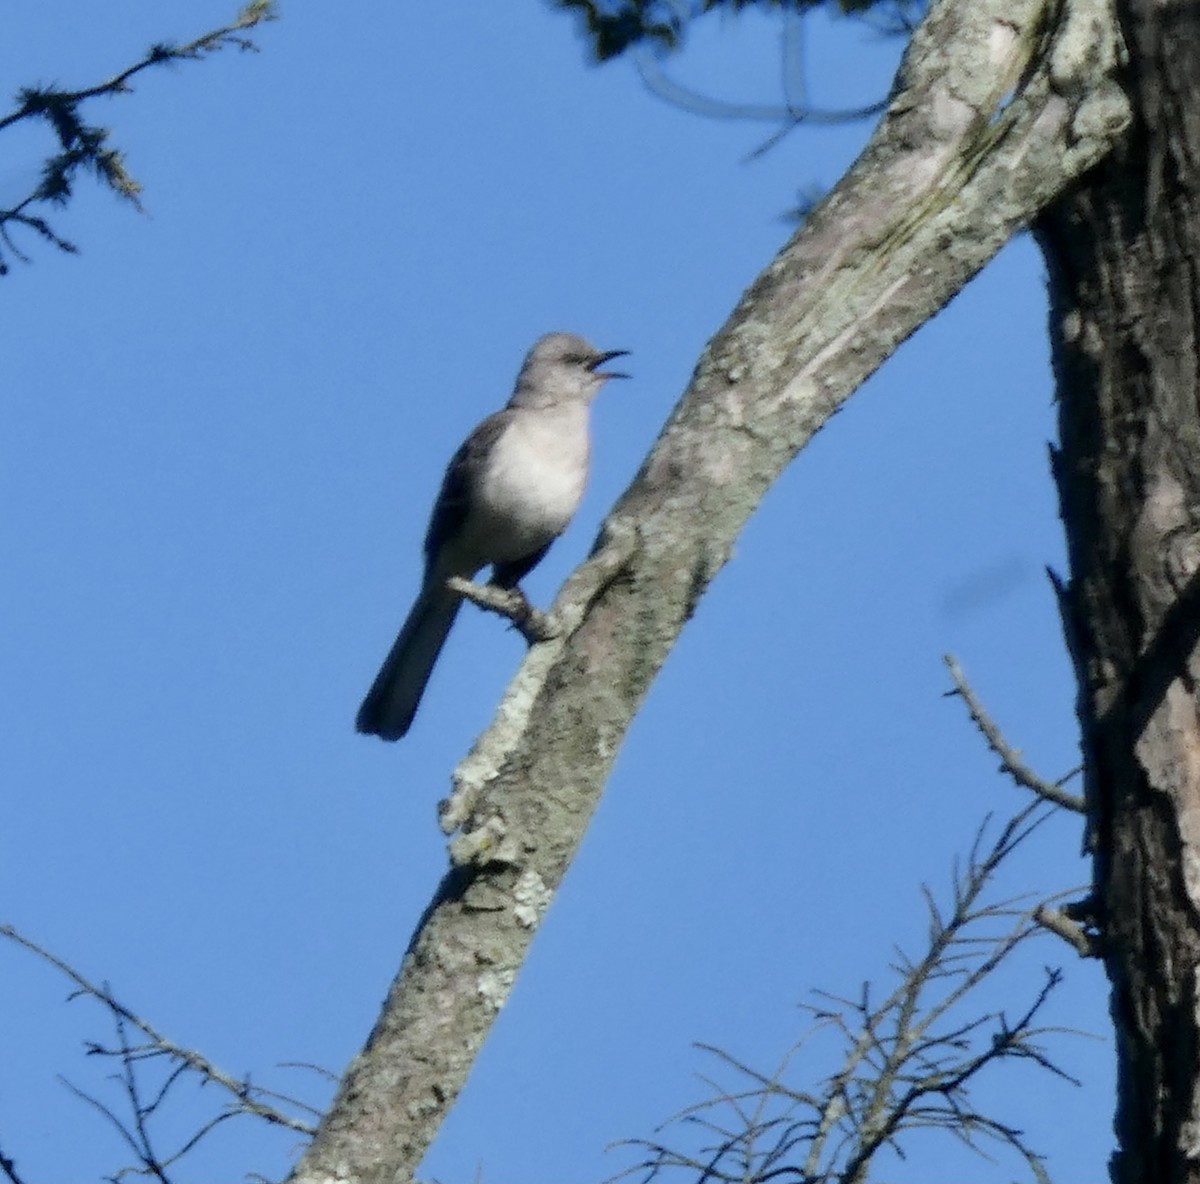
[0,0,1112,1184]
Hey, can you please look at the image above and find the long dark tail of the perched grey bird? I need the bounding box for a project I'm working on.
[355,581,462,740]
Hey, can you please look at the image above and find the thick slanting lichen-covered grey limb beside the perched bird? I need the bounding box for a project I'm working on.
[292,0,1127,1184]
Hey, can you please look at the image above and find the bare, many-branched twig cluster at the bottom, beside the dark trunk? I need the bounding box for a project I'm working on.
[613,800,1073,1184]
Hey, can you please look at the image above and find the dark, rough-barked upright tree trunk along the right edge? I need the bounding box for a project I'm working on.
[1038,0,1200,1184]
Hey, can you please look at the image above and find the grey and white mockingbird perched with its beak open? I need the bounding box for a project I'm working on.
[356,333,628,740]
